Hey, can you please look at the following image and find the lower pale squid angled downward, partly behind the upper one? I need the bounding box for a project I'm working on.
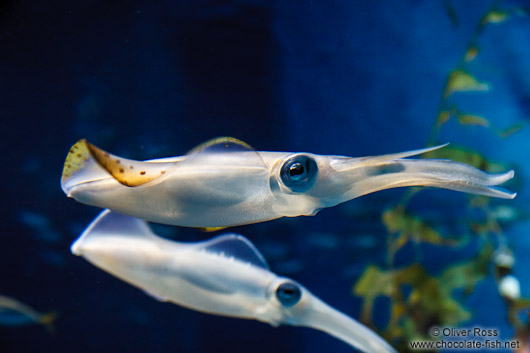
[71,210,395,352]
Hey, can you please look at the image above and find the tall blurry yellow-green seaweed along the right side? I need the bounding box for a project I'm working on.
[353,1,530,352]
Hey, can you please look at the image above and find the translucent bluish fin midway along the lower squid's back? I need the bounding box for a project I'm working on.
[199,234,269,270]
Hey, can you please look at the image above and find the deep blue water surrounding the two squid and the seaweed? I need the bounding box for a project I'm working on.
[0,0,530,353]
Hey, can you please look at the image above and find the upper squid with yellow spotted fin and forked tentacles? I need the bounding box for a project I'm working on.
[61,137,516,228]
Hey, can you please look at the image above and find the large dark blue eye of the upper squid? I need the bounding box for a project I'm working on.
[280,155,318,192]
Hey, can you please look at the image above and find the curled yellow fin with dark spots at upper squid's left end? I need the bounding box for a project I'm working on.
[61,139,170,188]
